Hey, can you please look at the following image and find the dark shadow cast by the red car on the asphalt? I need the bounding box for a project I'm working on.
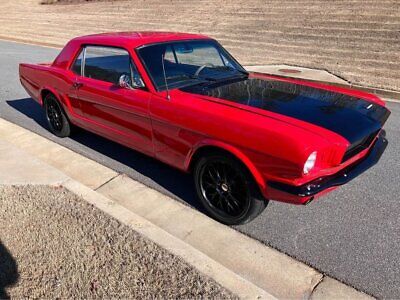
[6,98,204,212]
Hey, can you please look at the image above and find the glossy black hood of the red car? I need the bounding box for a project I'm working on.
[181,78,390,144]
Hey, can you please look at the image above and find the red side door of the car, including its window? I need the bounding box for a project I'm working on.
[73,46,153,155]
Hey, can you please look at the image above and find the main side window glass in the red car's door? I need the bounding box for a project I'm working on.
[83,46,132,85]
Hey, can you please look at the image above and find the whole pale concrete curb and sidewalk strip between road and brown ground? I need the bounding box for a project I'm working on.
[0,119,369,299]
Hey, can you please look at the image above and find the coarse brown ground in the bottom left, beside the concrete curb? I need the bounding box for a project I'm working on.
[0,186,235,299]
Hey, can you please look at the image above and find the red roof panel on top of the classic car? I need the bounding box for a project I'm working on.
[74,31,210,48]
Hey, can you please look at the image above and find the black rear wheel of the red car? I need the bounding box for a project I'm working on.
[44,94,72,138]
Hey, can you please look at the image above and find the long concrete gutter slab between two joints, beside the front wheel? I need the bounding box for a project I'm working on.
[97,175,322,299]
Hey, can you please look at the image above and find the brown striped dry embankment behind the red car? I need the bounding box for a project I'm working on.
[0,0,400,91]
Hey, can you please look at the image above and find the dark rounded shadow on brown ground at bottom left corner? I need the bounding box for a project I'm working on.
[0,241,19,299]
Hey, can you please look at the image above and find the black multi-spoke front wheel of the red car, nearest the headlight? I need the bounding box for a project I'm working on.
[194,154,268,225]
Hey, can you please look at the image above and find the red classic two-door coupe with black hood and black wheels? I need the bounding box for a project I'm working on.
[20,32,390,224]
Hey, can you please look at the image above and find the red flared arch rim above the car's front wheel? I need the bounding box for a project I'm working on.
[185,141,266,190]
